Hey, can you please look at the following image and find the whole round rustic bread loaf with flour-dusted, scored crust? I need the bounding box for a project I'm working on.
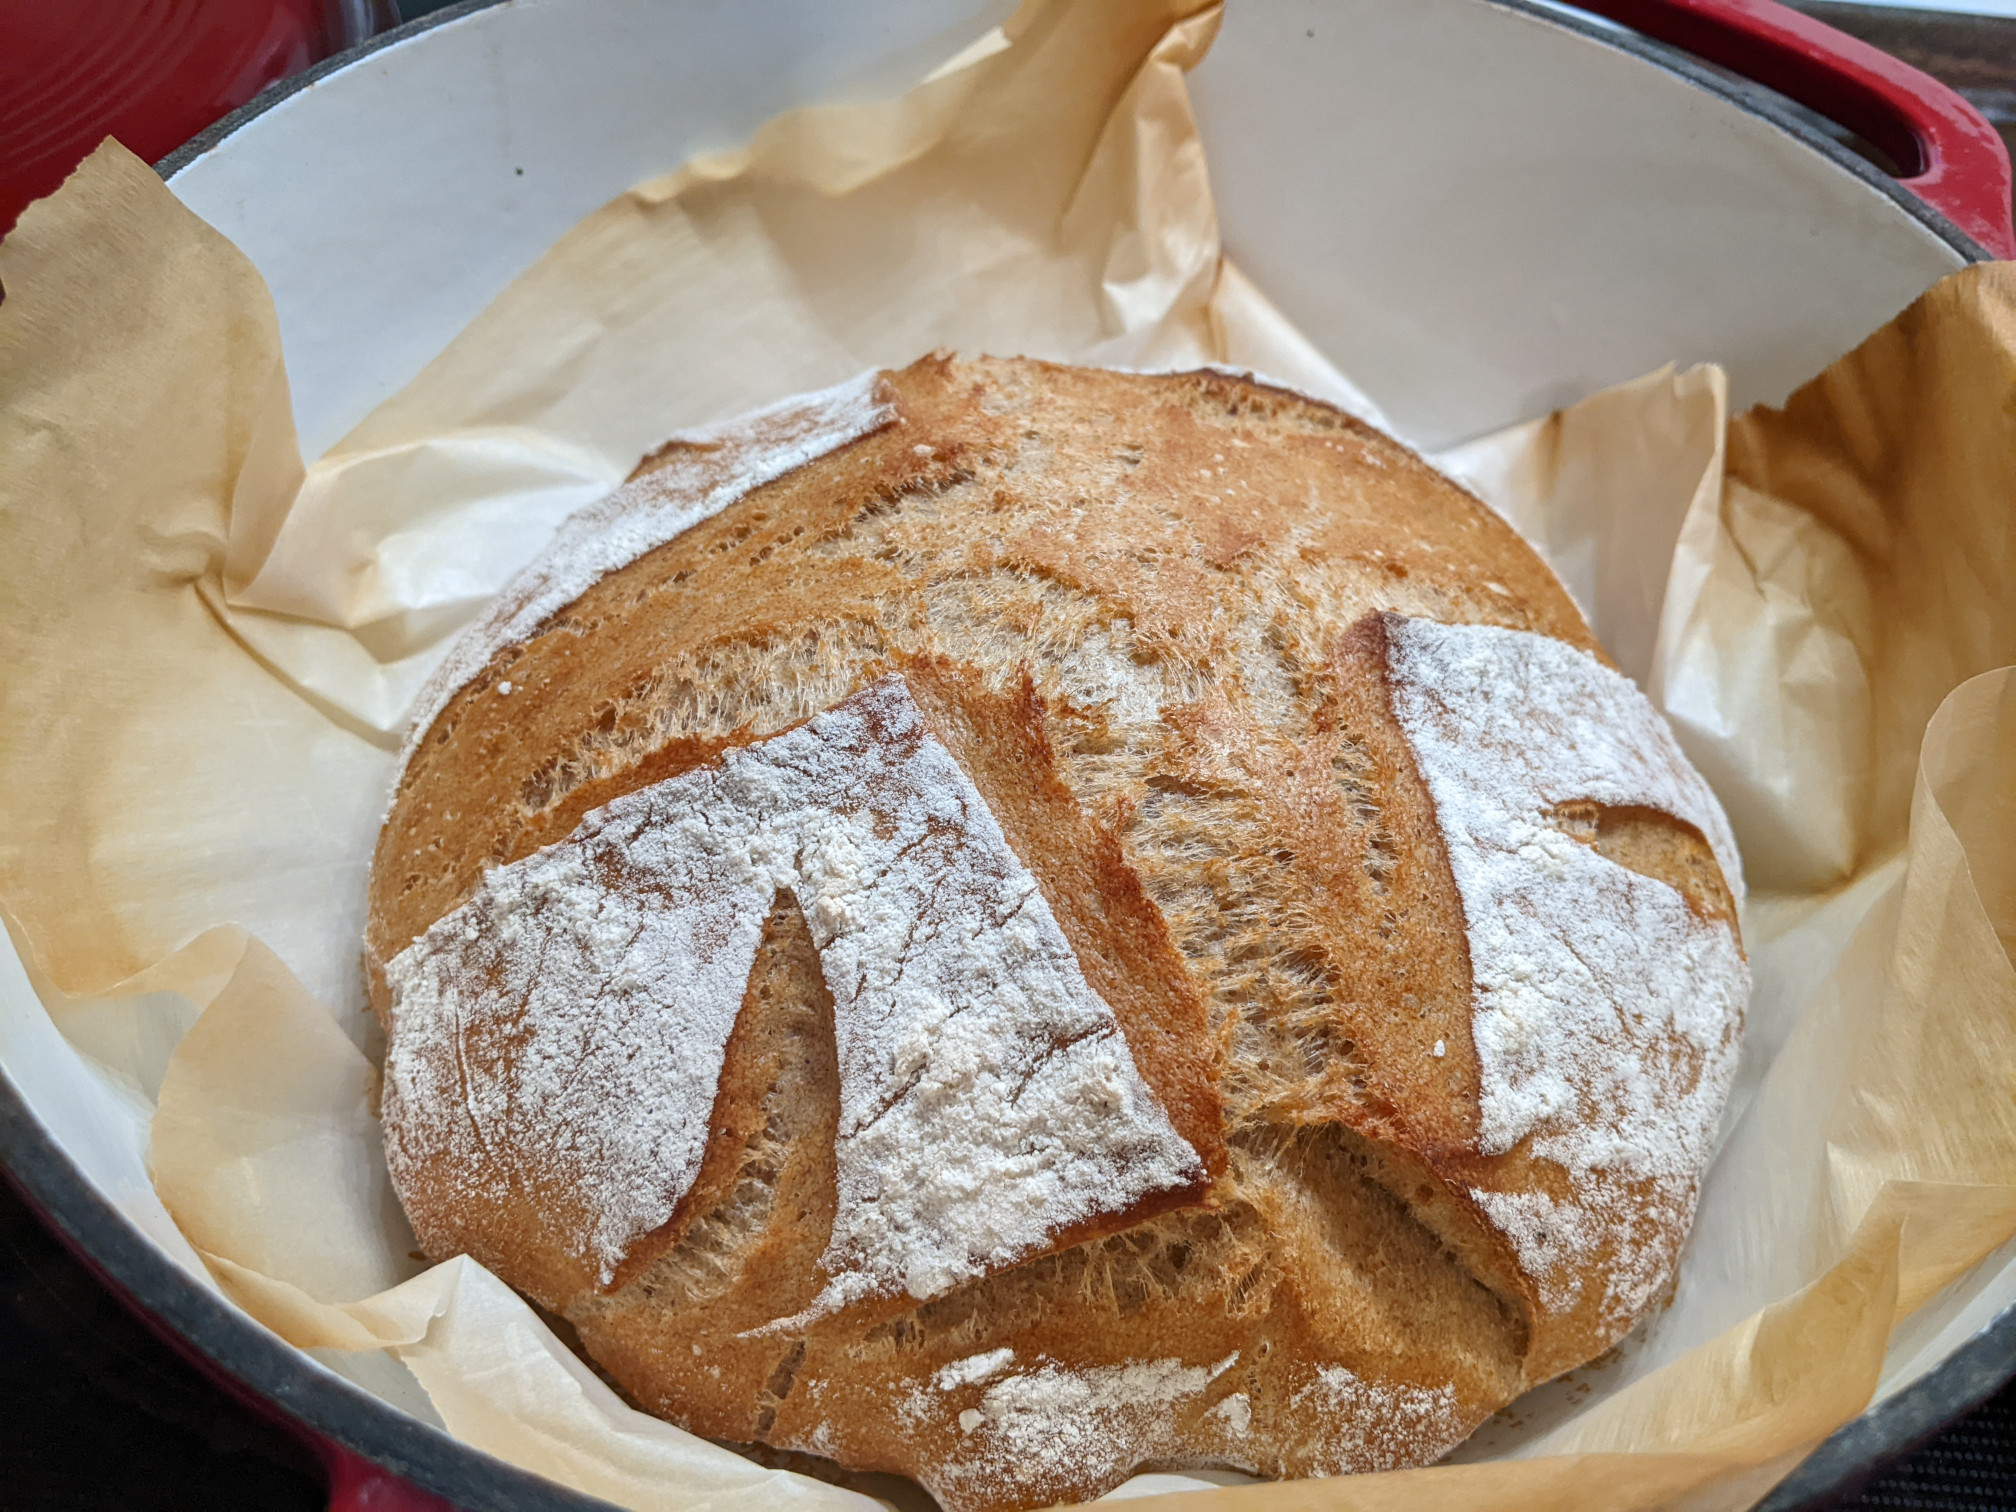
[365,357,1748,1512]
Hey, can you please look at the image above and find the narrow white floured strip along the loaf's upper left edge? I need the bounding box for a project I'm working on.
[393,371,897,790]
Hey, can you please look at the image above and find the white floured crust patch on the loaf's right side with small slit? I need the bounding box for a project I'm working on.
[1387,615,1750,1316]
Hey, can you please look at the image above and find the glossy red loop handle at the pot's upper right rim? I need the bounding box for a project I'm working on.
[1572,0,2016,260]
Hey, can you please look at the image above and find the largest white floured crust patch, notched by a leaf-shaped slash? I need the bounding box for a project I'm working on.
[385,677,1204,1312]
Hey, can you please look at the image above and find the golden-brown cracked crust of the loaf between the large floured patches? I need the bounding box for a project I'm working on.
[367,357,1734,1512]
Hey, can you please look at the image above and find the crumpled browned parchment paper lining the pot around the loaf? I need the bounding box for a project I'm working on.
[0,0,2016,1512]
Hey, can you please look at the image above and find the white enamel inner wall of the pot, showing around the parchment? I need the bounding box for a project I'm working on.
[0,0,1991,1510]
